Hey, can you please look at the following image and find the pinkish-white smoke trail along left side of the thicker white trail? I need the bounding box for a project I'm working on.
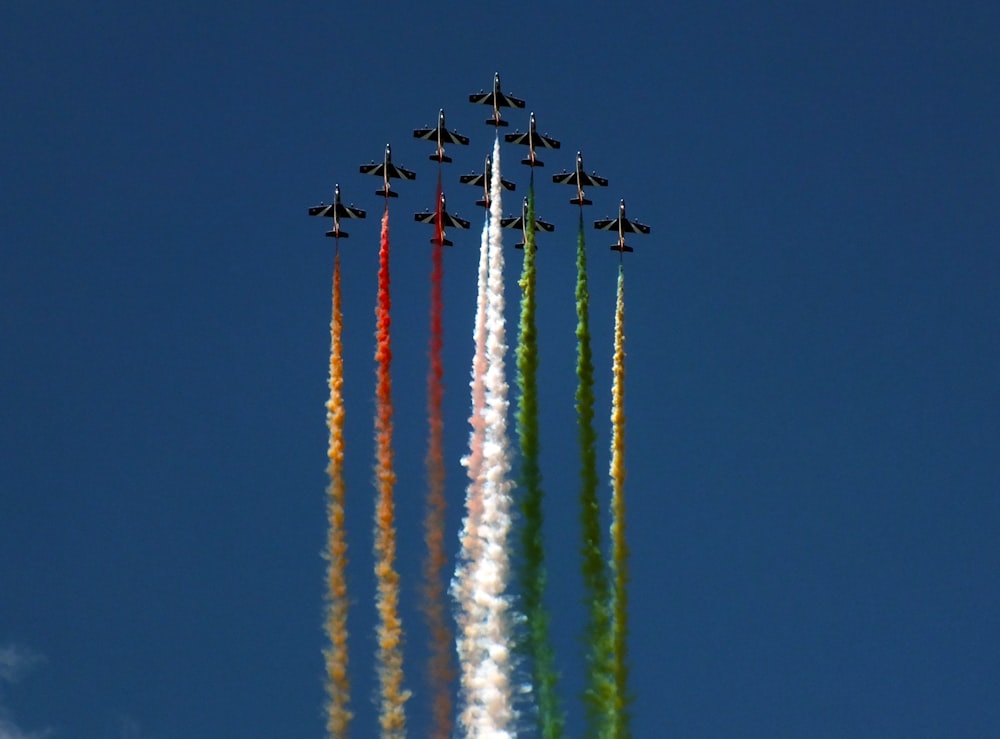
[451,213,490,735]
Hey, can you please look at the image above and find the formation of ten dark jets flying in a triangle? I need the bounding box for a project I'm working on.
[309,72,650,255]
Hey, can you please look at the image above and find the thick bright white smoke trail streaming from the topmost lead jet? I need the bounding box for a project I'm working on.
[460,136,514,739]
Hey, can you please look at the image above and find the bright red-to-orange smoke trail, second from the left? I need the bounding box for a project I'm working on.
[375,203,410,739]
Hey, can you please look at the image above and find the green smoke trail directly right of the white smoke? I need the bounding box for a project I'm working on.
[517,175,564,739]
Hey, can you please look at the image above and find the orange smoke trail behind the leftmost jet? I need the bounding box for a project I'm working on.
[323,251,352,738]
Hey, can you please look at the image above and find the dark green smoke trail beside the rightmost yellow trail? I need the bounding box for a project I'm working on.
[576,207,615,739]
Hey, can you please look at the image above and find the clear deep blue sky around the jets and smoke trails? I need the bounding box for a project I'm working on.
[0,0,1000,739]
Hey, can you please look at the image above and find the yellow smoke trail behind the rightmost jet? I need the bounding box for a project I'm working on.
[611,264,631,739]
